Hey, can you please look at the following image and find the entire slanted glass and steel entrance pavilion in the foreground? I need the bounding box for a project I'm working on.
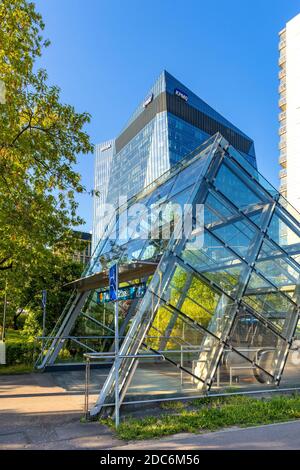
[36,134,300,415]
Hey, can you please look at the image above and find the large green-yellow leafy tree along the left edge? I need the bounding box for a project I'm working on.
[0,0,93,326]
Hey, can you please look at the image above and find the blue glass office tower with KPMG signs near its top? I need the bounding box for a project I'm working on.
[93,71,256,248]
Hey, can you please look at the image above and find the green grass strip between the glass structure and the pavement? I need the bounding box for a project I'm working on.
[102,394,300,440]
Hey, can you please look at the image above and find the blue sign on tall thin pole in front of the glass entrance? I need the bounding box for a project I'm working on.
[109,264,120,428]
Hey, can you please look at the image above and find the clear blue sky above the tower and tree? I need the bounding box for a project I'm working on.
[35,0,300,231]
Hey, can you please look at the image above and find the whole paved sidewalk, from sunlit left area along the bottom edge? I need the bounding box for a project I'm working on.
[0,372,300,451]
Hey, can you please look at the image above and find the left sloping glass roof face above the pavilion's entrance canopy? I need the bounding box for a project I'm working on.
[85,136,221,275]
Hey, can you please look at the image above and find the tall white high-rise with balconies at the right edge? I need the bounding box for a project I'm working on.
[279,14,300,211]
